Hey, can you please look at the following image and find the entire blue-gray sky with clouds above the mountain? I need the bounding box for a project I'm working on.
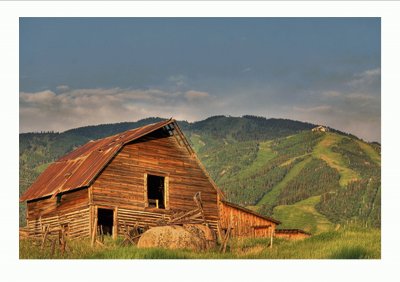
[19,18,381,142]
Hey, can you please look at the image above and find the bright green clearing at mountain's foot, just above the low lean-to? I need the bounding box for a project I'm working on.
[273,196,334,234]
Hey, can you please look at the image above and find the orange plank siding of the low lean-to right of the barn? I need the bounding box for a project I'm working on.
[219,202,276,237]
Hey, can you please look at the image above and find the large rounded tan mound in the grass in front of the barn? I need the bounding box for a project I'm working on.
[138,224,216,251]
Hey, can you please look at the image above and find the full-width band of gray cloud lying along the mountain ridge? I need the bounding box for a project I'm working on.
[20,65,381,141]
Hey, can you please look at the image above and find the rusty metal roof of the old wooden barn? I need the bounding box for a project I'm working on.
[20,119,175,201]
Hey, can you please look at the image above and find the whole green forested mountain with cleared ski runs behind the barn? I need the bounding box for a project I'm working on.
[20,116,381,233]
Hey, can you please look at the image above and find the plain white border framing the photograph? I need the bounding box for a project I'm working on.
[0,1,400,282]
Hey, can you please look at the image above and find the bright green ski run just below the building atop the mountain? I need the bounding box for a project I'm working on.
[313,132,360,187]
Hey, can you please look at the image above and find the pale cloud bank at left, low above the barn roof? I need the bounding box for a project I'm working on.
[20,87,218,132]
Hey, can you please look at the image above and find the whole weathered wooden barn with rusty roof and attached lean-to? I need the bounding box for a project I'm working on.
[20,119,279,238]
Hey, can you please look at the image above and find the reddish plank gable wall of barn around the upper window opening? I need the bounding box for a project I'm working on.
[91,135,218,229]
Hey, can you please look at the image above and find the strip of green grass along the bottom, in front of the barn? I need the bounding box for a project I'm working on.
[19,227,381,259]
